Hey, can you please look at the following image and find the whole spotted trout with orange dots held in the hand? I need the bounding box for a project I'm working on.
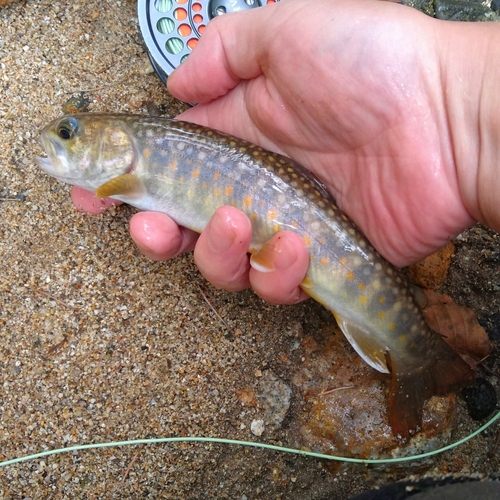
[35,113,473,441]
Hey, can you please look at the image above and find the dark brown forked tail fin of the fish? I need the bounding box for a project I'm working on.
[389,334,474,440]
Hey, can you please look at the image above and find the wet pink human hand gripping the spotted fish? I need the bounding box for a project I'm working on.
[74,0,500,302]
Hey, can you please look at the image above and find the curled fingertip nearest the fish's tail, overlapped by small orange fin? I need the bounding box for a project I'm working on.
[250,231,309,304]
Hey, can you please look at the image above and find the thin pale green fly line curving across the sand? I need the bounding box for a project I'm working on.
[0,411,500,467]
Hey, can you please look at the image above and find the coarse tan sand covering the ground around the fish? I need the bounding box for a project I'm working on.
[0,0,499,500]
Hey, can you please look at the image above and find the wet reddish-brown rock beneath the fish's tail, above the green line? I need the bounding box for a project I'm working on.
[293,328,455,458]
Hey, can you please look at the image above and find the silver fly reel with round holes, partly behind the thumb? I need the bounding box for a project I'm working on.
[137,0,280,83]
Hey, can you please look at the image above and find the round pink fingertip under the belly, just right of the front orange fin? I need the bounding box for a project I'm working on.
[130,212,198,260]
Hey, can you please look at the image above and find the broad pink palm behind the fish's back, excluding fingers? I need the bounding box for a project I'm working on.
[170,1,472,265]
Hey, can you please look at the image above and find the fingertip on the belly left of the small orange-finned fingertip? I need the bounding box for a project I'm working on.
[194,207,252,292]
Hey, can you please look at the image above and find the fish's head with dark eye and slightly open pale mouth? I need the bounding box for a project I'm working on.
[35,113,138,191]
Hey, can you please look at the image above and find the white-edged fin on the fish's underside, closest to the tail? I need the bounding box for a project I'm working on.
[334,313,389,373]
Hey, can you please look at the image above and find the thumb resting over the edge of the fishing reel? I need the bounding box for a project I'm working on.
[167,5,275,103]
